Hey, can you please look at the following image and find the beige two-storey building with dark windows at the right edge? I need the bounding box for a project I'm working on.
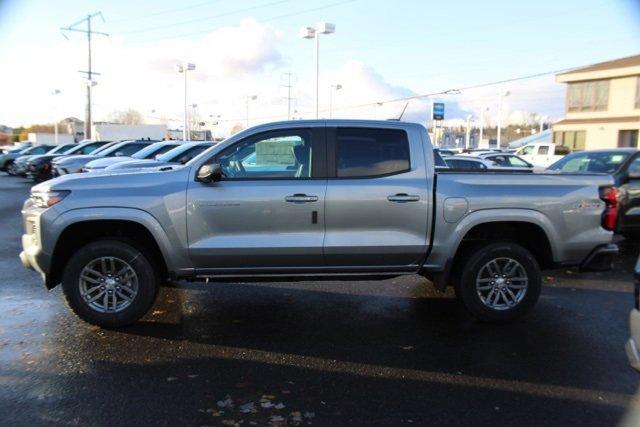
[553,55,640,150]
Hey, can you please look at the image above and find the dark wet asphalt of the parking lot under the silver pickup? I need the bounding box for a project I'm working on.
[0,176,640,426]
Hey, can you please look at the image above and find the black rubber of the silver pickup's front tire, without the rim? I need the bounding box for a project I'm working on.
[62,240,159,328]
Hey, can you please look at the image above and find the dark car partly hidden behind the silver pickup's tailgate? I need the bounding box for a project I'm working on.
[547,148,640,239]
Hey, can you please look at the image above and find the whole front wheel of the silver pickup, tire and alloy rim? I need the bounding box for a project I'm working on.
[62,240,158,328]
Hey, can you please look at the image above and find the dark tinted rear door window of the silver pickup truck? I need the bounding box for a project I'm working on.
[336,128,411,178]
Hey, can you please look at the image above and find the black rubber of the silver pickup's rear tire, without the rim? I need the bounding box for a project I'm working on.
[456,242,542,322]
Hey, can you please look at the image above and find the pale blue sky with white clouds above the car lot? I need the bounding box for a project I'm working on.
[0,0,640,133]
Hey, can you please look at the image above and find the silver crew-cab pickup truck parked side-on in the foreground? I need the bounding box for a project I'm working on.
[20,120,617,327]
